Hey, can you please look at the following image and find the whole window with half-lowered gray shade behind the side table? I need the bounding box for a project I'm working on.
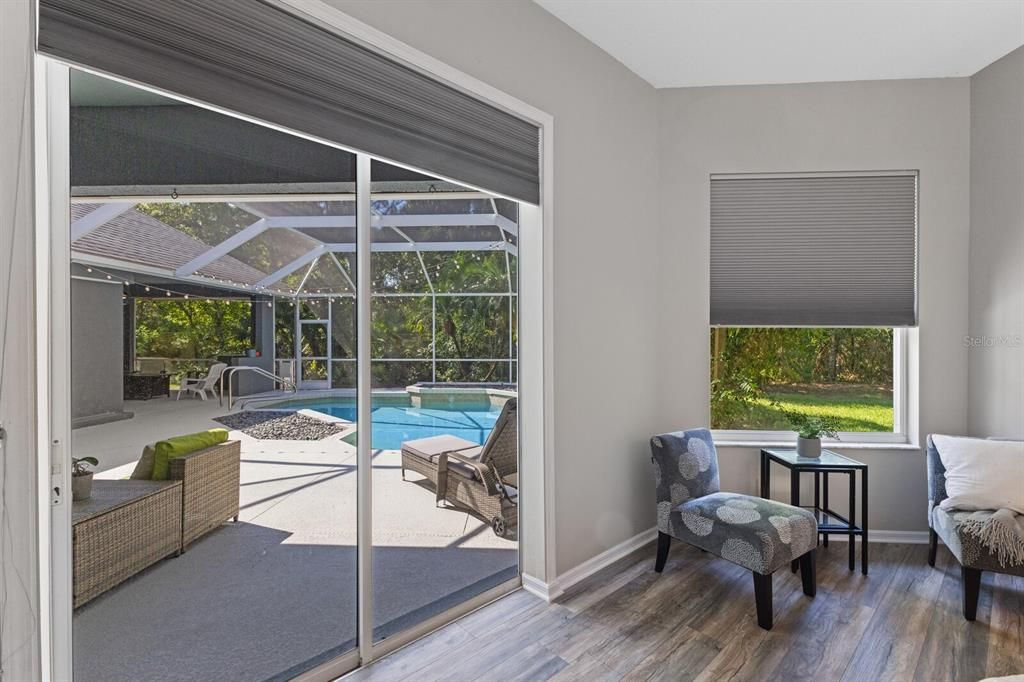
[710,166,918,442]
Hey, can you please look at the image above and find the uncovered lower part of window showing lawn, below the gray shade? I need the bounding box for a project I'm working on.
[710,327,905,441]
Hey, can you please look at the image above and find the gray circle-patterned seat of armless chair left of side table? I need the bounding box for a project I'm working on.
[658,493,818,576]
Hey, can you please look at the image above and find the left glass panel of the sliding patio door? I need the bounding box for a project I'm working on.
[65,66,369,682]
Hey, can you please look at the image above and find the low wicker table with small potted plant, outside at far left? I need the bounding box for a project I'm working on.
[72,480,181,608]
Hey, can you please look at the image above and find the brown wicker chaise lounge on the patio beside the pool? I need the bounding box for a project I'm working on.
[401,398,519,537]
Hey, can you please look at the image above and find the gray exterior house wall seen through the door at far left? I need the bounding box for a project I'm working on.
[71,280,124,424]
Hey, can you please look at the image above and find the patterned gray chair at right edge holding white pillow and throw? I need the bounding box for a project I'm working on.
[926,436,1024,621]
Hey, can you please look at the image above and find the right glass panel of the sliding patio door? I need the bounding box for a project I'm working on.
[370,162,519,642]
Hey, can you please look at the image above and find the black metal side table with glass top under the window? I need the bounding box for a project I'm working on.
[761,449,867,576]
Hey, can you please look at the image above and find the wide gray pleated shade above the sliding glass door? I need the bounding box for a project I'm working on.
[39,0,540,204]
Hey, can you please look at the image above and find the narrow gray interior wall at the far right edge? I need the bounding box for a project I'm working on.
[965,47,1024,438]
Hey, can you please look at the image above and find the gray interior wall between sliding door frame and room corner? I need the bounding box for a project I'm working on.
[331,0,666,579]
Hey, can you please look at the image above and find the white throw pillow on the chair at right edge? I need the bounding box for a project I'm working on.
[932,435,1024,514]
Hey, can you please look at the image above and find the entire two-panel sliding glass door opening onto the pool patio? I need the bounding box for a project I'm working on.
[60,69,519,680]
